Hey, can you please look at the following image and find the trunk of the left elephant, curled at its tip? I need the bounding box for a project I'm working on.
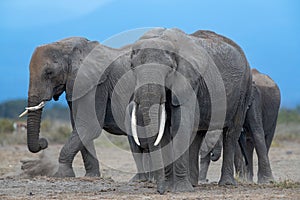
[27,96,48,153]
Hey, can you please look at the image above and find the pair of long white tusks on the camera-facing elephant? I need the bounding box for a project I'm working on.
[131,103,167,146]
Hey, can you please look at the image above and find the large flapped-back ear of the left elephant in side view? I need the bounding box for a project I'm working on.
[67,40,128,101]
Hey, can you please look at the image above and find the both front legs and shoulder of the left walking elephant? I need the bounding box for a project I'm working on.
[55,87,107,176]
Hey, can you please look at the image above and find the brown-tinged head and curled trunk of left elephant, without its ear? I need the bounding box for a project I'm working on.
[27,38,98,153]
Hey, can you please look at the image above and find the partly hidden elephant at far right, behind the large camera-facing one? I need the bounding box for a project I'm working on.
[199,69,281,183]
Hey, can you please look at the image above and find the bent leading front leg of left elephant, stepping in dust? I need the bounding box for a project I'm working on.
[54,130,83,177]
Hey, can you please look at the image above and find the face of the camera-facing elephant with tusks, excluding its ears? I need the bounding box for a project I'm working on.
[131,39,176,146]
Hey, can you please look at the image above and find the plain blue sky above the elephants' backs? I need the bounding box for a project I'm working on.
[0,0,300,107]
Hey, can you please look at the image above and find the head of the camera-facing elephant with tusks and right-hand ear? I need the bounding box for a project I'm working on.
[131,29,214,145]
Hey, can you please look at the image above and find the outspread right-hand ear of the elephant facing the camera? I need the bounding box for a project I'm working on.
[161,29,211,106]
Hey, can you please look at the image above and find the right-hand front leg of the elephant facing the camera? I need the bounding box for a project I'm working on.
[171,106,194,192]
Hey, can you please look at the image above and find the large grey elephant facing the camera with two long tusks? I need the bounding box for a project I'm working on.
[130,29,252,191]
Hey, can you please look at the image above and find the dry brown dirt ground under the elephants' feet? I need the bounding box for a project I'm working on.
[0,134,300,200]
